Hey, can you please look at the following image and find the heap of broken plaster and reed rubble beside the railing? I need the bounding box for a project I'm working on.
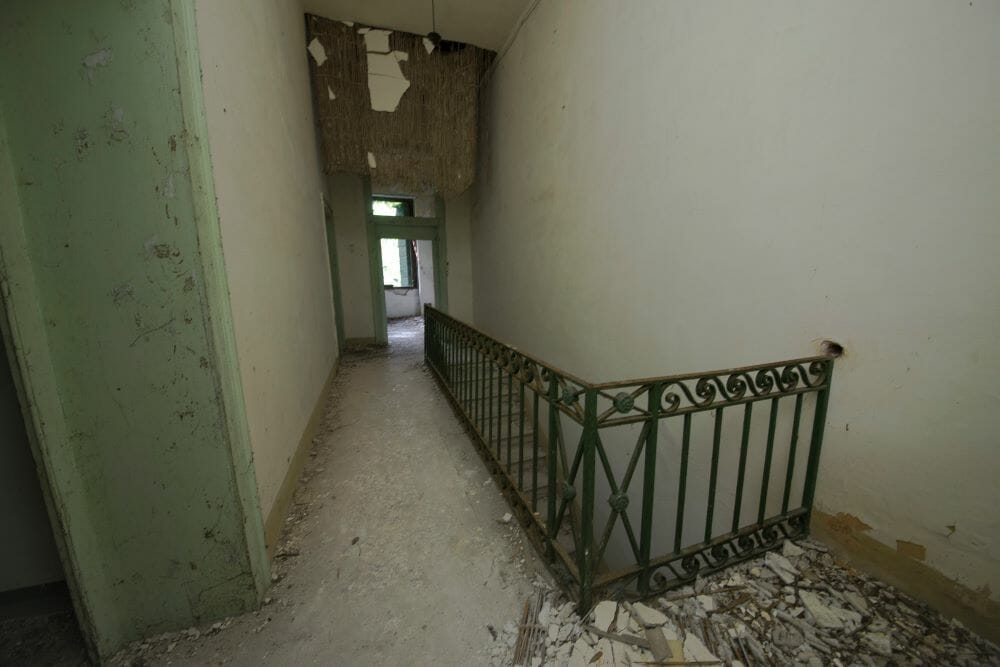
[490,540,1000,667]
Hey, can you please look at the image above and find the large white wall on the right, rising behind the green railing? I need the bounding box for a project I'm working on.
[474,0,1000,600]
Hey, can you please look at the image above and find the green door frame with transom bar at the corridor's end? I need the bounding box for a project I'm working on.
[364,178,448,345]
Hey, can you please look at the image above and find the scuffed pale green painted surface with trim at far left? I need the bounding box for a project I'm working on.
[0,0,267,654]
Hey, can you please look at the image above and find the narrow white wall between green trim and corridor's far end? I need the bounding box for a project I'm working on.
[197,0,337,516]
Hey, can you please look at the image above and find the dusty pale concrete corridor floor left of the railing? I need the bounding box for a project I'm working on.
[110,318,547,665]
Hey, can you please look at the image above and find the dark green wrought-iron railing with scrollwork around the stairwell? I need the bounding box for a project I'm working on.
[424,306,833,609]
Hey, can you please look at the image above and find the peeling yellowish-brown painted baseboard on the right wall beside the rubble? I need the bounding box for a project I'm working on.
[810,509,1000,643]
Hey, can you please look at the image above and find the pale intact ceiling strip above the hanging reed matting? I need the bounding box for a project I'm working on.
[303,0,529,51]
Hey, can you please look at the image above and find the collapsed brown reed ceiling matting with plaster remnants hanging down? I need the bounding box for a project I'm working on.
[307,16,493,195]
